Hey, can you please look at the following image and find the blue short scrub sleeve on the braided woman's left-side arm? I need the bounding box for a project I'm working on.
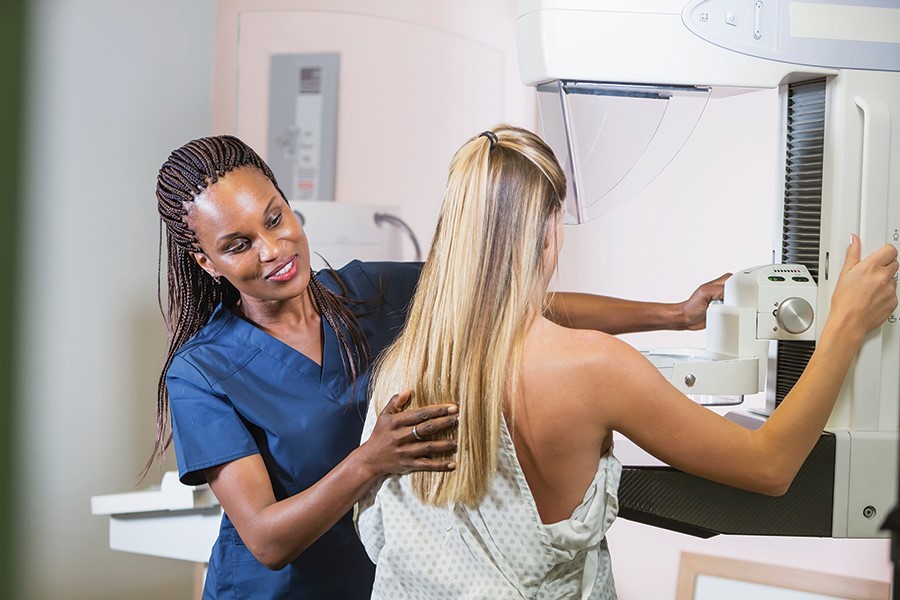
[166,355,259,485]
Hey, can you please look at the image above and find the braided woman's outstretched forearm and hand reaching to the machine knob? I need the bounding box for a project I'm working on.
[544,273,731,335]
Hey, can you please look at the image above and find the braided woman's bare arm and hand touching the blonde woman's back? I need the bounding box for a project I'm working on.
[204,392,458,569]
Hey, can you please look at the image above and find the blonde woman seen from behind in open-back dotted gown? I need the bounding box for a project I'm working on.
[358,125,897,600]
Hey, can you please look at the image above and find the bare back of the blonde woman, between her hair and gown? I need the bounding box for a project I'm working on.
[507,318,612,524]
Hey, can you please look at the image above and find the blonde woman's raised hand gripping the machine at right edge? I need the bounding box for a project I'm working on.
[829,235,897,339]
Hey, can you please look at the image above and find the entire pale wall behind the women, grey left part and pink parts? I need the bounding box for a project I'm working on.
[17,0,889,599]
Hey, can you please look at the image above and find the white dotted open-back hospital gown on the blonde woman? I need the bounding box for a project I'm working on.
[357,407,622,600]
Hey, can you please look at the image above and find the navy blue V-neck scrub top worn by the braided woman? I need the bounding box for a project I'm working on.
[166,261,421,600]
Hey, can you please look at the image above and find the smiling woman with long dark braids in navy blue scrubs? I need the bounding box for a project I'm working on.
[148,136,724,600]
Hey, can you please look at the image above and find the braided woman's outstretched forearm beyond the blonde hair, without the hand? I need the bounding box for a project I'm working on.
[545,292,685,335]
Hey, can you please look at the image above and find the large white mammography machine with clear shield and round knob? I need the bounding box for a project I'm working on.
[517,0,900,538]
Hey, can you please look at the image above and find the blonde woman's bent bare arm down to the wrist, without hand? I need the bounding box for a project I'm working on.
[624,321,862,496]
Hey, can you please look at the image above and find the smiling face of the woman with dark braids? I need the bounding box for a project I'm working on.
[186,167,309,311]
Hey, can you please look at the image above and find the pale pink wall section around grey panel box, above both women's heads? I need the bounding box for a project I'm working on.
[213,0,536,252]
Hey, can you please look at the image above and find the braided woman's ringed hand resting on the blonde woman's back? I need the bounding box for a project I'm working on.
[360,391,459,476]
